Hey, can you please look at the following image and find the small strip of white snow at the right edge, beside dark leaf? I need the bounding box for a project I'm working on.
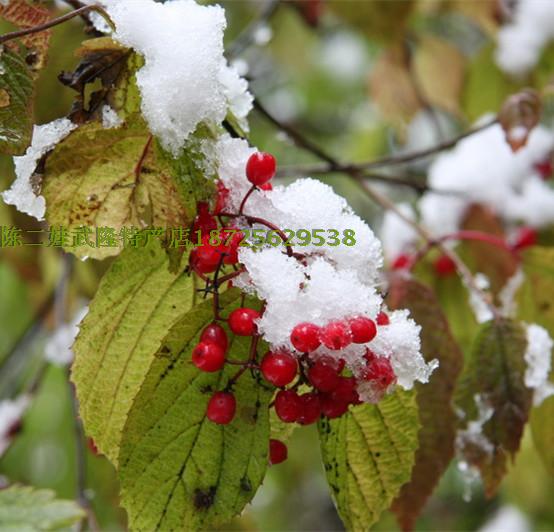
[525,323,554,406]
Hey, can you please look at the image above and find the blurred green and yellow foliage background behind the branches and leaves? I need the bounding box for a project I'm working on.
[0,0,554,532]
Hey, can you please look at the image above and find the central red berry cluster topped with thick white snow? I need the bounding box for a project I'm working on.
[190,144,437,440]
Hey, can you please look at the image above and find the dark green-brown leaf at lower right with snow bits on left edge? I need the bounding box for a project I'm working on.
[455,319,533,497]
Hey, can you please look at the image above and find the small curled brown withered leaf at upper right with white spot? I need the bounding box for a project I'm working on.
[498,89,542,152]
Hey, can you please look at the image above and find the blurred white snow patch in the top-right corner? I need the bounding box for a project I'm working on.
[495,0,554,76]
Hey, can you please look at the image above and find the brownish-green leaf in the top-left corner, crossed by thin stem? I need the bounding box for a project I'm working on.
[0,0,50,155]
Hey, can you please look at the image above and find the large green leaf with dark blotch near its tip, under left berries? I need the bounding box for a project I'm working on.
[119,289,273,530]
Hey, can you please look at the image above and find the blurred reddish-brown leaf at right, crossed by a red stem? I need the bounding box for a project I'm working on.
[462,204,518,294]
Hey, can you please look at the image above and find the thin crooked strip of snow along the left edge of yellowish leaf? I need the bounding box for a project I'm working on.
[2,118,77,221]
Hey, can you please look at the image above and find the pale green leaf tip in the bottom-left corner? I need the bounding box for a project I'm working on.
[0,486,85,532]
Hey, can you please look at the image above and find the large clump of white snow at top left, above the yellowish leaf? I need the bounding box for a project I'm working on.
[103,0,251,155]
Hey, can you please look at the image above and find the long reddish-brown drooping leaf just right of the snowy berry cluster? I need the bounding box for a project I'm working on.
[388,277,463,530]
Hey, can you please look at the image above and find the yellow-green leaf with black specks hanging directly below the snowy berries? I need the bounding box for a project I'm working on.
[319,390,419,530]
